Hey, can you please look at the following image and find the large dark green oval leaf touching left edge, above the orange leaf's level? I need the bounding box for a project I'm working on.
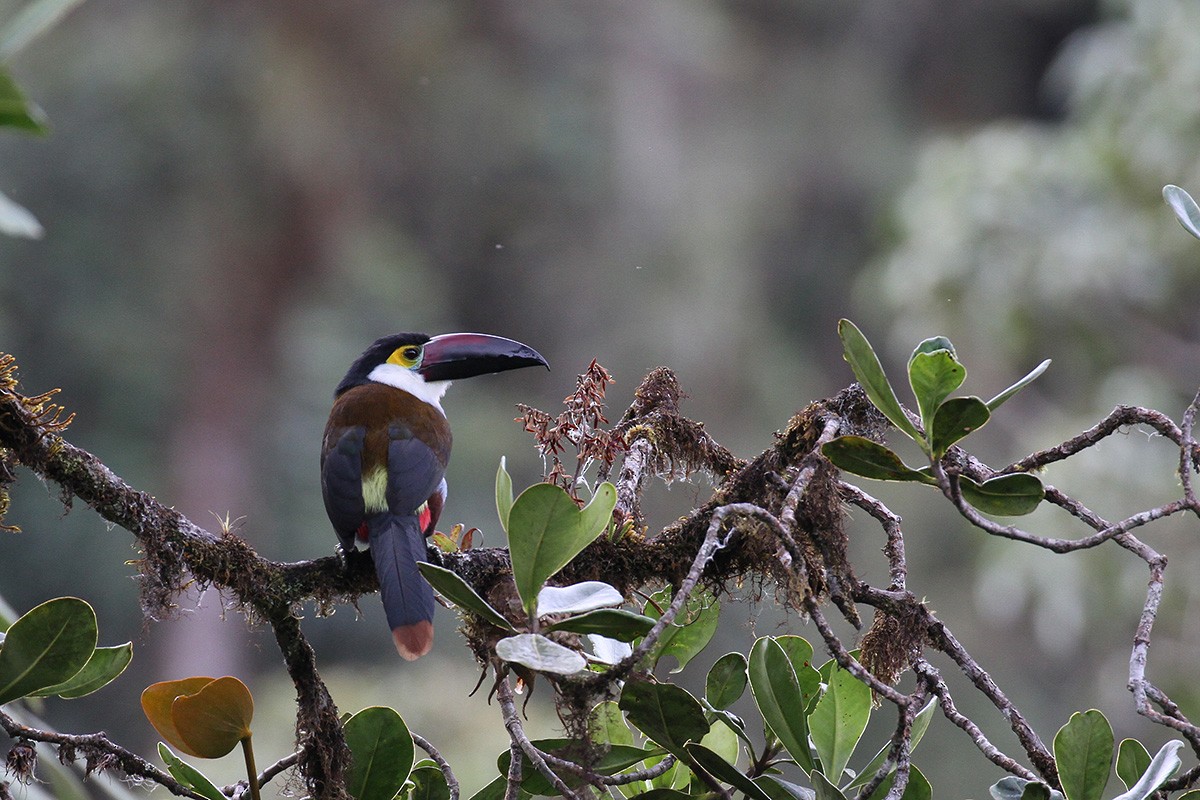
[0,597,97,705]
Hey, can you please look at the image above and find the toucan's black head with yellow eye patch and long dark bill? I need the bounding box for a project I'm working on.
[334,333,550,397]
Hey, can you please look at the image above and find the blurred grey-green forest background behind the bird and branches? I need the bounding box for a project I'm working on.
[0,0,1200,796]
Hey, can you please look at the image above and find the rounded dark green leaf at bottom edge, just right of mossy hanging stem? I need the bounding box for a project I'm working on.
[343,705,415,800]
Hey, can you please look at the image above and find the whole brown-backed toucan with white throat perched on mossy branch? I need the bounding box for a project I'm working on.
[320,333,550,661]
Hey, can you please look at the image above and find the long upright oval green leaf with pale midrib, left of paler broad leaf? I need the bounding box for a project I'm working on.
[748,637,814,772]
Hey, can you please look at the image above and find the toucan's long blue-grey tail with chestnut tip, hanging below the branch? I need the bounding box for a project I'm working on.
[367,513,434,661]
